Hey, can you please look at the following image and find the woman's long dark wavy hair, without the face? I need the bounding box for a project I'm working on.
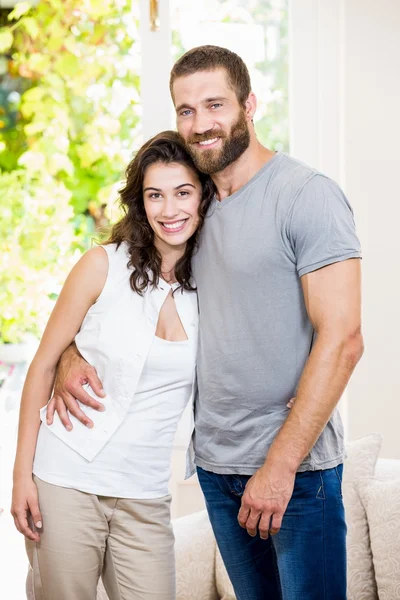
[106,131,215,295]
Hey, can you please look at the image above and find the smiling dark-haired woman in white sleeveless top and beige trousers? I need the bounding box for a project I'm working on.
[12,131,214,600]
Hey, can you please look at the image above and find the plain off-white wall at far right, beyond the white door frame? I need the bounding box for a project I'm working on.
[344,0,400,458]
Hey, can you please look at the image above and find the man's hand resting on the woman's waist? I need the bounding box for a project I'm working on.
[46,343,105,431]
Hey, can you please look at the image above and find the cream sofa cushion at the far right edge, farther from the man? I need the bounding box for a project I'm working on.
[359,479,400,600]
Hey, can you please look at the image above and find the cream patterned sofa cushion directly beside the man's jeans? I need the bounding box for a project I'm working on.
[343,433,382,600]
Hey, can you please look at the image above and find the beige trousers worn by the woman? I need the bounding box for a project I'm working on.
[26,477,175,600]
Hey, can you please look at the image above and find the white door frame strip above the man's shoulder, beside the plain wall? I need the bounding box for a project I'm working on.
[289,0,345,185]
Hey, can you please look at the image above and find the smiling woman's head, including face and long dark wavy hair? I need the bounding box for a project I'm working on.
[110,131,214,293]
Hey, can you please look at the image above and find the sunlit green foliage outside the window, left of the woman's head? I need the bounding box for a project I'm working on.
[0,0,140,341]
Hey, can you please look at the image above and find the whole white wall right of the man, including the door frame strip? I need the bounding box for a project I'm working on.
[291,0,400,458]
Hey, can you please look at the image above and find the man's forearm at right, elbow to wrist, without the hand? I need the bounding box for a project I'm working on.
[265,332,363,473]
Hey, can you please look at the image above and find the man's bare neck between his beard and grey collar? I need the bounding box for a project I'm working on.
[212,137,275,201]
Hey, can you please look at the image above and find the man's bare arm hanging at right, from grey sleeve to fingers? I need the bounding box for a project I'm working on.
[238,259,363,539]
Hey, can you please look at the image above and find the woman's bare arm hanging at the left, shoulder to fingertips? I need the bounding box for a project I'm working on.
[11,247,108,541]
